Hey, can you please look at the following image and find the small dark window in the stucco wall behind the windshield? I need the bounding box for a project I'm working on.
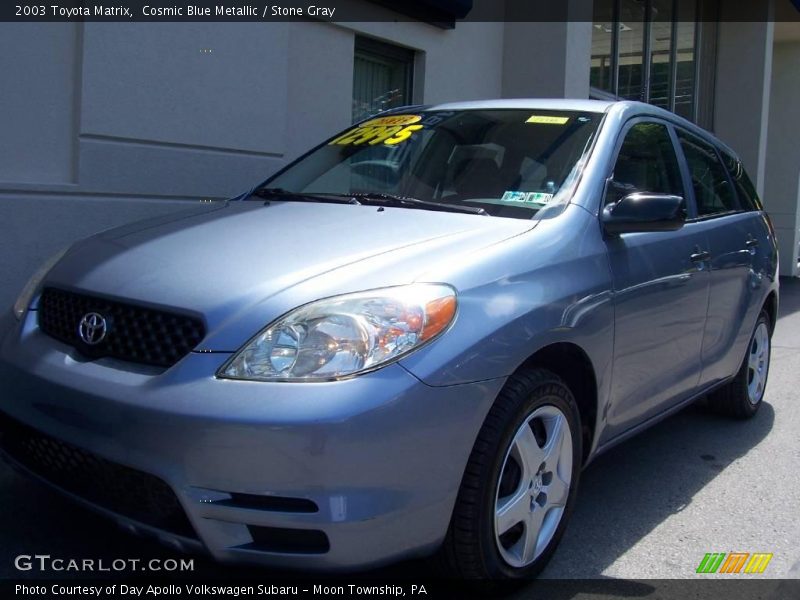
[353,36,414,122]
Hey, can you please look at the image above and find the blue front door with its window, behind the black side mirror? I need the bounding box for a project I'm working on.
[604,119,710,439]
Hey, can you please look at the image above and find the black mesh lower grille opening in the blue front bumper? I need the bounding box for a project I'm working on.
[0,413,197,539]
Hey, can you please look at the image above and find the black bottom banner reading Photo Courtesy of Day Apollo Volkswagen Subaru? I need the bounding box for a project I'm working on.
[0,578,800,600]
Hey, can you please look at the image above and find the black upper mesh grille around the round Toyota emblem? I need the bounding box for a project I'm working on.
[38,288,205,367]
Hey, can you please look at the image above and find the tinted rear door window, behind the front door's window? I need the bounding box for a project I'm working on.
[678,131,739,217]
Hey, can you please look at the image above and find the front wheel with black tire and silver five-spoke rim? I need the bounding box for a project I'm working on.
[438,369,582,581]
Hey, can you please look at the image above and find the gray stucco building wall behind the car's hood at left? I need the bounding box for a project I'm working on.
[0,17,503,307]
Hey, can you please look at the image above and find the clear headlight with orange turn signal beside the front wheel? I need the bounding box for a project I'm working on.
[217,284,456,381]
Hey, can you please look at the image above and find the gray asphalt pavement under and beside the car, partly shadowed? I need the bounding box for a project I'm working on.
[0,279,800,584]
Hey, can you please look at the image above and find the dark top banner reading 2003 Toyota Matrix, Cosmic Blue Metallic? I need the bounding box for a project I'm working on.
[0,0,800,23]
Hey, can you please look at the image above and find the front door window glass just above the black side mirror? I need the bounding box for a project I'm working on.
[606,123,684,204]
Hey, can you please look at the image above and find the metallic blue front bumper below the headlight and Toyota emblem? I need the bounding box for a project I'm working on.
[0,313,503,570]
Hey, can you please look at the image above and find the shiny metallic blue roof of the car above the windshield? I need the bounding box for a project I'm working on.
[387,98,739,160]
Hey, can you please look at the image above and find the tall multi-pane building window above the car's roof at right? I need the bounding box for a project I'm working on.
[590,0,718,127]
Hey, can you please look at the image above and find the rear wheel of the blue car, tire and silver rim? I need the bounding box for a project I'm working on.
[708,311,772,419]
